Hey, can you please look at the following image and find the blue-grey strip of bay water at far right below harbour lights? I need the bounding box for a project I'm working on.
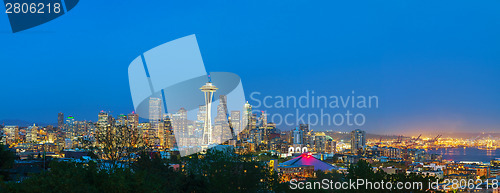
[427,147,500,162]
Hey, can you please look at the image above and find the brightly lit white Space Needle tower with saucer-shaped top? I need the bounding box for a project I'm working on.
[200,82,217,145]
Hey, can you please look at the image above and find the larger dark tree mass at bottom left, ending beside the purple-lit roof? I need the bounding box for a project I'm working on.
[0,151,285,193]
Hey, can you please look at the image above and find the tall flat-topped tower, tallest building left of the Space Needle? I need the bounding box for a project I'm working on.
[149,97,163,145]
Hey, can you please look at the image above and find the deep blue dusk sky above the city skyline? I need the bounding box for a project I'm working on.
[0,0,500,133]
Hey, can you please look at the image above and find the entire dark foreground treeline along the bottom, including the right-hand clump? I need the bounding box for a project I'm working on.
[0,135,435,193]
